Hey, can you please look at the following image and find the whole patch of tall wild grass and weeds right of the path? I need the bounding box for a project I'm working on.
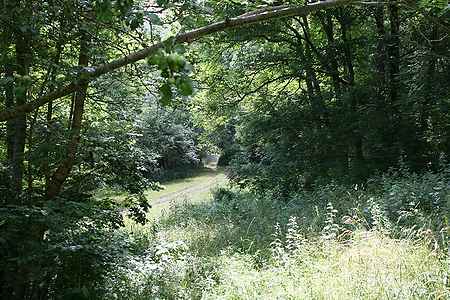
[103,175,450,299]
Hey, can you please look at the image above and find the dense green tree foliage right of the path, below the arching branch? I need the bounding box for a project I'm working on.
[195,1,449,193]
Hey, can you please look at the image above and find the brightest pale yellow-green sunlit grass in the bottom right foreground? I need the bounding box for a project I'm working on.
[204,232,450,299]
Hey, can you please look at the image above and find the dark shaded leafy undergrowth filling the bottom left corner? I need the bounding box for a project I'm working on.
[0,199,127,299]
